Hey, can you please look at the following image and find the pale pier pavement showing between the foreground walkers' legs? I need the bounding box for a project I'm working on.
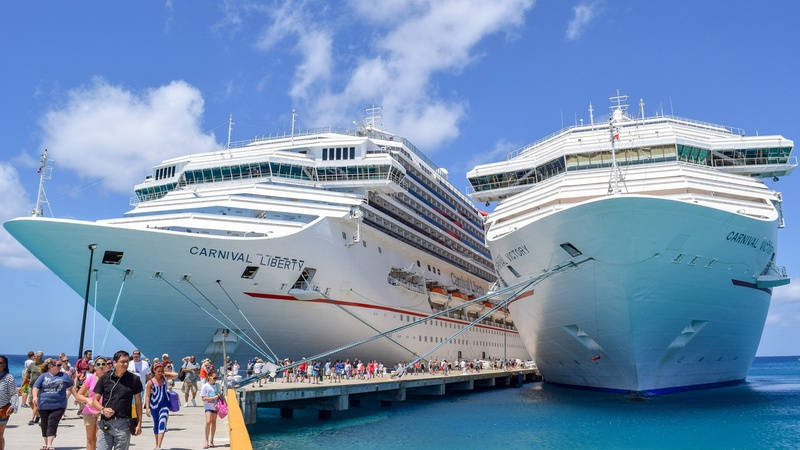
[5,382,233,450]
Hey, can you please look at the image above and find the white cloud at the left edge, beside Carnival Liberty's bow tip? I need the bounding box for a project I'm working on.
[0,162,44,269]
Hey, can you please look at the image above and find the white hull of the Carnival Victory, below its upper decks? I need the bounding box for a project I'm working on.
[488,195,777,392]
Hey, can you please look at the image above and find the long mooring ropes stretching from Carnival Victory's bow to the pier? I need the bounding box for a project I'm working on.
[234,257,594,389]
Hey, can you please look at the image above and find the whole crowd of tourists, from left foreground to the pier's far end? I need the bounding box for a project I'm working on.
[0,350,521,450]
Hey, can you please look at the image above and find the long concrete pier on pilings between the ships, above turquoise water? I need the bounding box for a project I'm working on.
[236,369,541,425]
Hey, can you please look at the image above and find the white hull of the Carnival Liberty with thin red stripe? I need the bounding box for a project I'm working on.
[5,218,528,363]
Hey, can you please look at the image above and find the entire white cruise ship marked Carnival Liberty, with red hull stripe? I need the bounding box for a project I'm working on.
[9,117,529,364]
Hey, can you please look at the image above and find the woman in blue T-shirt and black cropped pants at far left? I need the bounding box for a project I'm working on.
[33,358,75,450]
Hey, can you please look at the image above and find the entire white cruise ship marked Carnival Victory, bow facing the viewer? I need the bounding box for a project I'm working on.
[468,93,797,395]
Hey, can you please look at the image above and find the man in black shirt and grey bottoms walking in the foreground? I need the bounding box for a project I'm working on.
[92,350,142,450]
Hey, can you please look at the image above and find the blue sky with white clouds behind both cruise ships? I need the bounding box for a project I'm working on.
[0,0,800,355]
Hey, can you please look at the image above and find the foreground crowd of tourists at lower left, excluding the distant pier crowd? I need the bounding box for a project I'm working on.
[0,350,227,450]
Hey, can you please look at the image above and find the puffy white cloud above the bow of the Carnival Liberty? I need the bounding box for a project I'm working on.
[41,78,219,192]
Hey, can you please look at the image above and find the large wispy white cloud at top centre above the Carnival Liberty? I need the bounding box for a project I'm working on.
[256,0,533,150]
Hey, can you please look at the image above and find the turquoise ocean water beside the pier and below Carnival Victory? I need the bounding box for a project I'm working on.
[249,356,800,450]
